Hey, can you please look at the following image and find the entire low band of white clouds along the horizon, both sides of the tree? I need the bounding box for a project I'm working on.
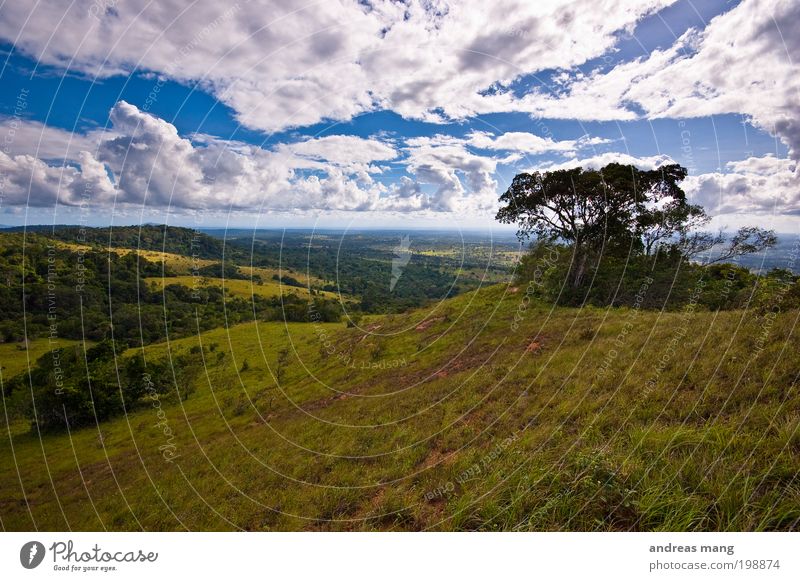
[0,101,800,220]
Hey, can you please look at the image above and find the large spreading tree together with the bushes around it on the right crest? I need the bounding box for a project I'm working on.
[497,163,800,309]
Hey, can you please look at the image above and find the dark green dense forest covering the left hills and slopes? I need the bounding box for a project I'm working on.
[0,228,342,429]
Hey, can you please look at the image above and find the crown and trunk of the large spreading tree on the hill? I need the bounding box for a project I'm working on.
[497,163,692,286]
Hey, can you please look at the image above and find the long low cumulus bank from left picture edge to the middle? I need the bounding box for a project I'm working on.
[0,101,396,210]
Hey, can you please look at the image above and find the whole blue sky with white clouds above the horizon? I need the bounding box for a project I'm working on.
[0,0,800,231]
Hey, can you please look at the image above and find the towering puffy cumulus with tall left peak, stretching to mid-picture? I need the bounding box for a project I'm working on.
[98,102,397,210]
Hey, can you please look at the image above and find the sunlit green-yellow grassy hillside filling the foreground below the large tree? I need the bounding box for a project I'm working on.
[0,285,800,530]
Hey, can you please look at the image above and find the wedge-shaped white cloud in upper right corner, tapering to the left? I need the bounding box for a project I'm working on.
[522,0,800,160]
